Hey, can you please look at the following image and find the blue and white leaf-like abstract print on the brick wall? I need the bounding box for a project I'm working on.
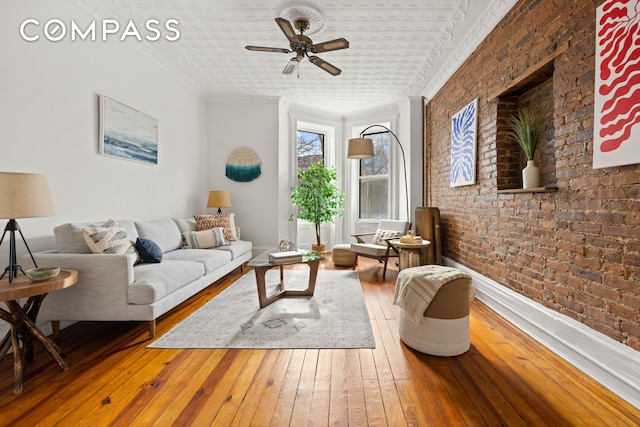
[450,98,478,187]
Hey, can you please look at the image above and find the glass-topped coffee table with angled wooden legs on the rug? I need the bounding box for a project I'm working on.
[248,249,324,308]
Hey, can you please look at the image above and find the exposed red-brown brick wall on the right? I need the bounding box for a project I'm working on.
[425,0,640,350]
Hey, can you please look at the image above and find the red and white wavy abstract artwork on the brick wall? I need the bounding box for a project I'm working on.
[593,0,640,168]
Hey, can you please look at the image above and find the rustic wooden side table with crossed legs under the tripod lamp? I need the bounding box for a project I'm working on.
[0,270,78,394]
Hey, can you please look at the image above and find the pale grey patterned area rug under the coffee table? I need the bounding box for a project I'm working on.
[149,269,375,348]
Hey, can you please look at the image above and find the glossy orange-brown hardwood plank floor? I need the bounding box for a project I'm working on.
[0,259,640,426]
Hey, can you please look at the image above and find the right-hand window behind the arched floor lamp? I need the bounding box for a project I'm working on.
[359,132,389,219]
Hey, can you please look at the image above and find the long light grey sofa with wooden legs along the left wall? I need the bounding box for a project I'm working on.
[20,218,252,338]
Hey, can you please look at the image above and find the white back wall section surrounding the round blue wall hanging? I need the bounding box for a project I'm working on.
[208,98,279,253]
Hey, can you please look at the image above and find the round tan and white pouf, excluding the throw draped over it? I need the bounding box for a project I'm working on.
[399,278,471,356]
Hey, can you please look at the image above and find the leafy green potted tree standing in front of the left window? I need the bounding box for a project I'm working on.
[290,161,344,252]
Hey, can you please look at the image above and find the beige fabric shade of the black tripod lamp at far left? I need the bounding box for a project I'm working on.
[0,172,56,219]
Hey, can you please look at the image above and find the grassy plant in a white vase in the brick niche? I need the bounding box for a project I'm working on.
[508,109,544,188]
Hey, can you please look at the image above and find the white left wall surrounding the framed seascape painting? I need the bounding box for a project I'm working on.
[0,0,208,269]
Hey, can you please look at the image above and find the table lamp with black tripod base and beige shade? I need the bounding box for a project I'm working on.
[0,172,55,283]
